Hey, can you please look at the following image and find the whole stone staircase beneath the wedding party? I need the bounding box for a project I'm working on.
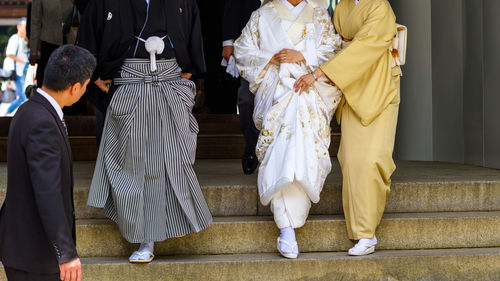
[0,160,500,281]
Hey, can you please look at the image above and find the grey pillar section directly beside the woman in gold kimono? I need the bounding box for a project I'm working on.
[391,0,433,161]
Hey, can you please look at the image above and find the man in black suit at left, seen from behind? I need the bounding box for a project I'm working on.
[0,45,96,281]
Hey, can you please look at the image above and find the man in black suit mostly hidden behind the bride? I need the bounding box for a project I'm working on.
[222,0,260,174]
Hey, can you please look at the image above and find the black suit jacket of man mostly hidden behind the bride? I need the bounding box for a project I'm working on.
[222,0,260,41]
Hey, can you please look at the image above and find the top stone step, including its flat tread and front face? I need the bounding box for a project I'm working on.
[0,158,500,219]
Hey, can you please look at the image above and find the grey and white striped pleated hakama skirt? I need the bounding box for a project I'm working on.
[88,59,212,243]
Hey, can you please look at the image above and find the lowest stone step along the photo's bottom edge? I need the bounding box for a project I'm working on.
[0,248,500,281]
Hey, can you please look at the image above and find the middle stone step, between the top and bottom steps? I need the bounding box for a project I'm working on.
[77,211,500,257]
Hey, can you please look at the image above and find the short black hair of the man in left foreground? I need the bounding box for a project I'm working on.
[43,45,96,91]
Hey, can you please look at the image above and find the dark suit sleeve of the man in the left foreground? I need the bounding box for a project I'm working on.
[25,121,78,264]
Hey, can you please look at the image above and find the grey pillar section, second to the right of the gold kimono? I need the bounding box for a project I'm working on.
[431,0,465,163]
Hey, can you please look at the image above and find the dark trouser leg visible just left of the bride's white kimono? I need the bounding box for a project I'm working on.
[238,78,259,157]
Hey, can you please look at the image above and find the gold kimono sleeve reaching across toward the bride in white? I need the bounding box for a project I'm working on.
[321,2,396,90]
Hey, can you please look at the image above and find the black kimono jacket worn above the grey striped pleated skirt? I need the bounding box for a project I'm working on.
[77,0,206,144]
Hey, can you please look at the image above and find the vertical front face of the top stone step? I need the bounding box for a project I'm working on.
[0,182,500,219]
